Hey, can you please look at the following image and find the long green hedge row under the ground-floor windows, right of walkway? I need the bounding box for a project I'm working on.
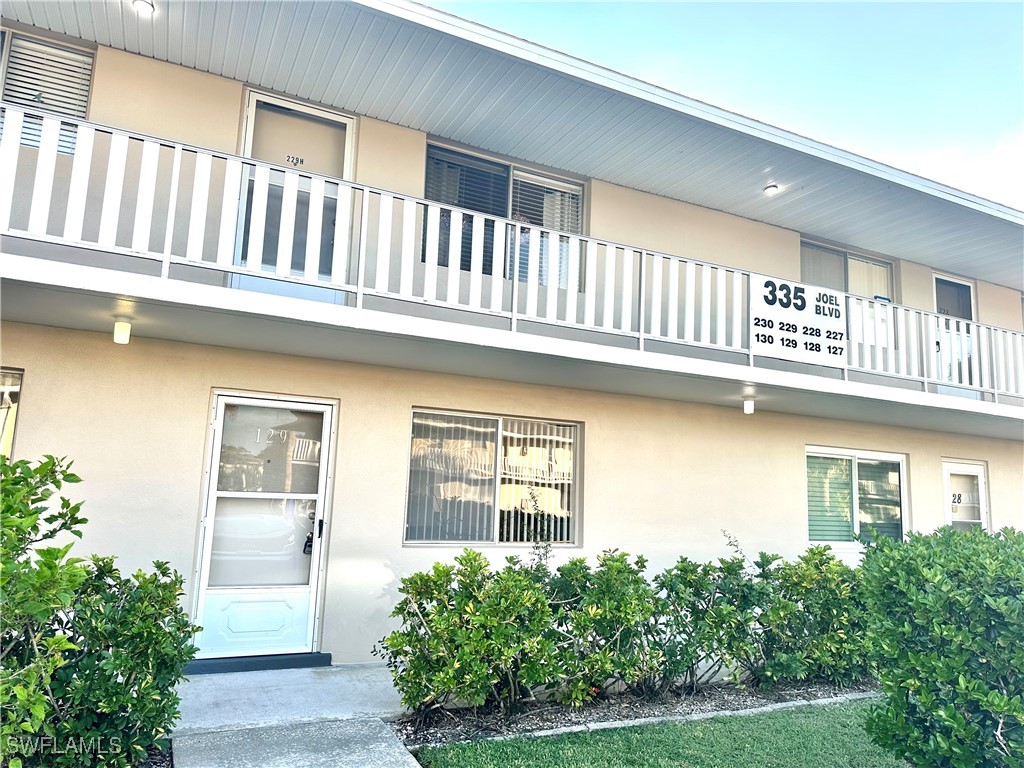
[375,547,868,717]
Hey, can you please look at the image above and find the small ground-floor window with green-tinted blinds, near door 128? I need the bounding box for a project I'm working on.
[807,453,903,542]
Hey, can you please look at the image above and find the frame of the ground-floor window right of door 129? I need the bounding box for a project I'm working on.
[401,407,584,549]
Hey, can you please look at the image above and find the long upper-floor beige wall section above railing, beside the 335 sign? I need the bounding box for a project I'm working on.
[588,179,800,280]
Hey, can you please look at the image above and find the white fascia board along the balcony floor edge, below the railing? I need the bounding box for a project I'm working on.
[0,254,1024,425]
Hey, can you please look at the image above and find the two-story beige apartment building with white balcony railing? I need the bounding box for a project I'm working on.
[0,0,1024,663]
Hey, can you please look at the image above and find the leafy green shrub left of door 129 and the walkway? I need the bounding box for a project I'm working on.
[0,456,196,768]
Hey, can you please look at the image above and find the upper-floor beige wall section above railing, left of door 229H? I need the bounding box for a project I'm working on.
[89,46,243,153]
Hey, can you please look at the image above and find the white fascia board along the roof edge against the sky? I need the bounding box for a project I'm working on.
[351,0,1024,226]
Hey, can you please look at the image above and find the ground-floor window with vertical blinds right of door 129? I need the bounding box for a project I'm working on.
[406,411,578,544]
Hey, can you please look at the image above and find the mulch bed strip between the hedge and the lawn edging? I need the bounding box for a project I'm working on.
[390,681,877,751]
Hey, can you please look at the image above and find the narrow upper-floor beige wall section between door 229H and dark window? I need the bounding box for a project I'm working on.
[355,118,427,198]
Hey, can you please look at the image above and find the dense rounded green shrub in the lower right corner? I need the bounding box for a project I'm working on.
[862,527,1024,768]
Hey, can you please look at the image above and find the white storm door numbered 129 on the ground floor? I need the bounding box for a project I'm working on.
[197,394,334,657]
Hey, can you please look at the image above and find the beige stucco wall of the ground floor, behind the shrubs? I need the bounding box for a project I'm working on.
[2,325,1024,663]
